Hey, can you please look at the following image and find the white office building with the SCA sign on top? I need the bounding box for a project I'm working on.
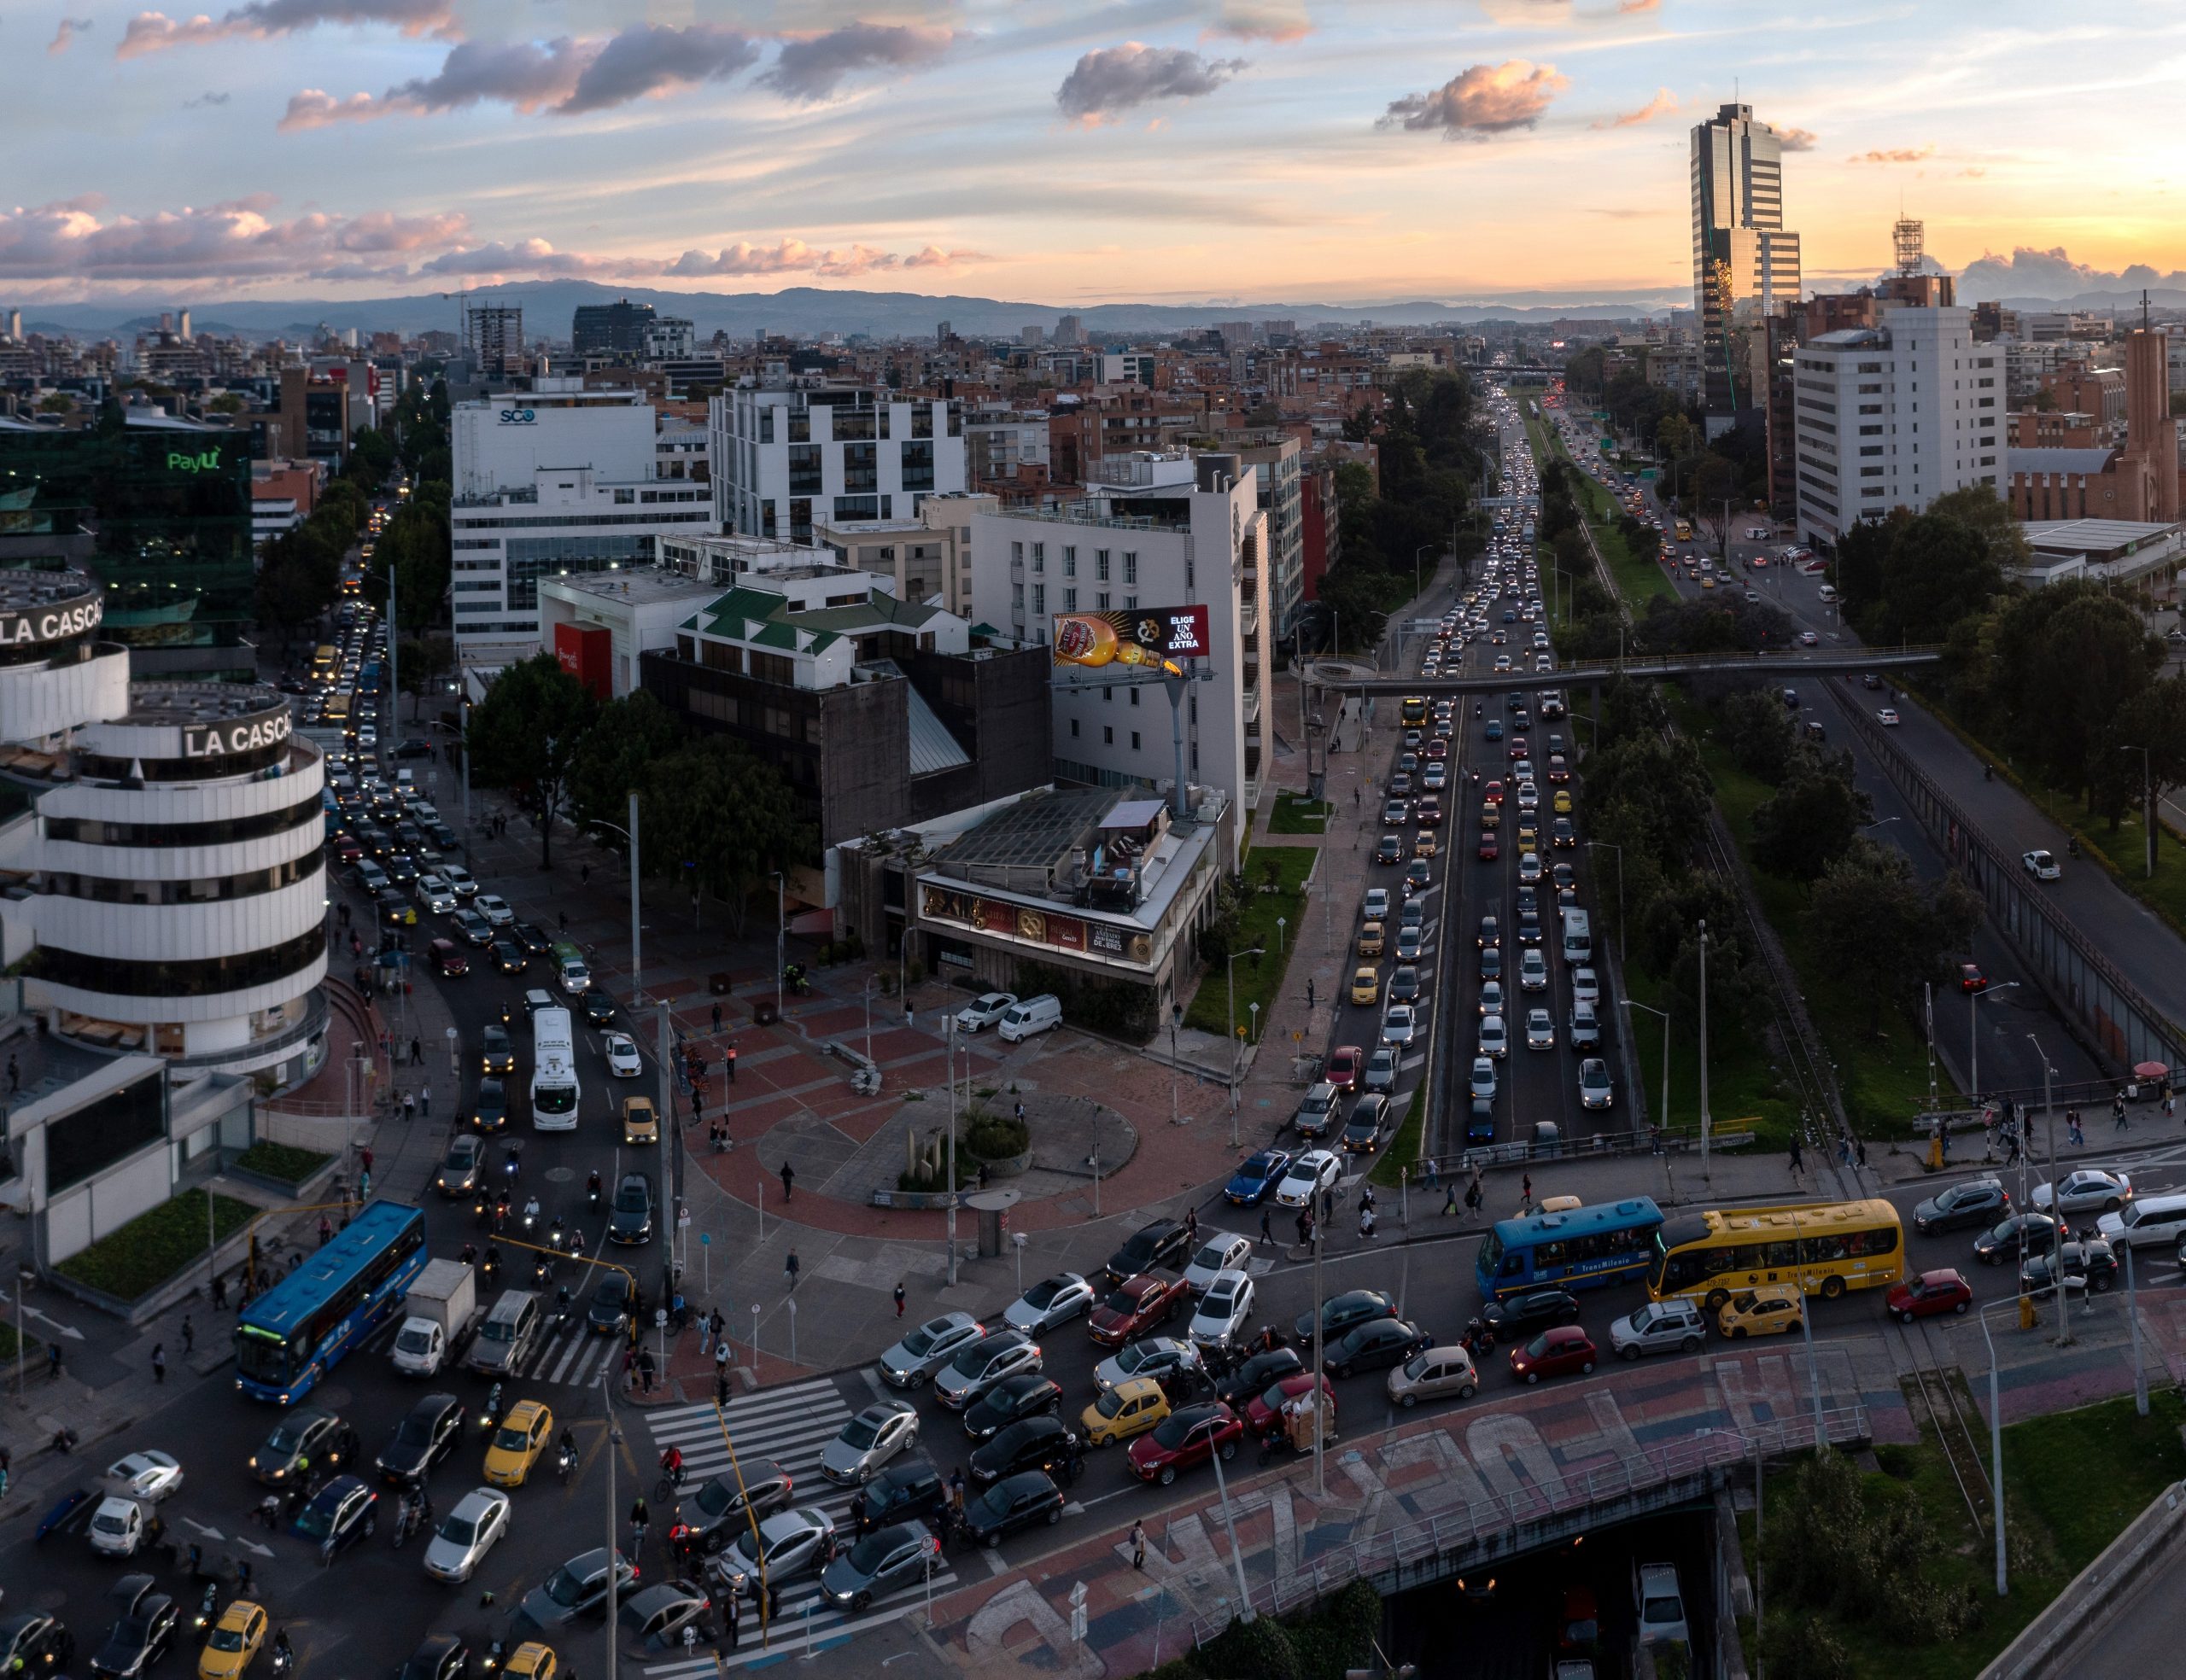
[448,378,715,667]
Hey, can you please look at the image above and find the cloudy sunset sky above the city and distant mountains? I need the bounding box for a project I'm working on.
[13,0,2186,306]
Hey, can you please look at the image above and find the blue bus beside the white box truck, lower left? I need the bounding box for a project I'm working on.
[236,1202,426,1405]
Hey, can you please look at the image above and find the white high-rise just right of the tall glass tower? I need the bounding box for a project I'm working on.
[1795,308,2005,544]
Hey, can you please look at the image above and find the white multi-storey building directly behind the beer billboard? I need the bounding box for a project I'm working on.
[971,454,1272,825]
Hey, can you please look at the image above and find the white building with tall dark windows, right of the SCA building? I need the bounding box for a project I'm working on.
[706,389,964,542]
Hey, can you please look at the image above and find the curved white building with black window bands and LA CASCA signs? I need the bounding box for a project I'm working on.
[0,573,325,1086]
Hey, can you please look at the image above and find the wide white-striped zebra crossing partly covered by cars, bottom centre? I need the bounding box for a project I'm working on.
[638,1380,957,1680]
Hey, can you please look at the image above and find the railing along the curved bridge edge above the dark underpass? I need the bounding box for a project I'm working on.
[1191,1405,1869,1648]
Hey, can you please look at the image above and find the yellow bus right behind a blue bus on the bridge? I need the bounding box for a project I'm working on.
[1646,1202,1906,1313]
